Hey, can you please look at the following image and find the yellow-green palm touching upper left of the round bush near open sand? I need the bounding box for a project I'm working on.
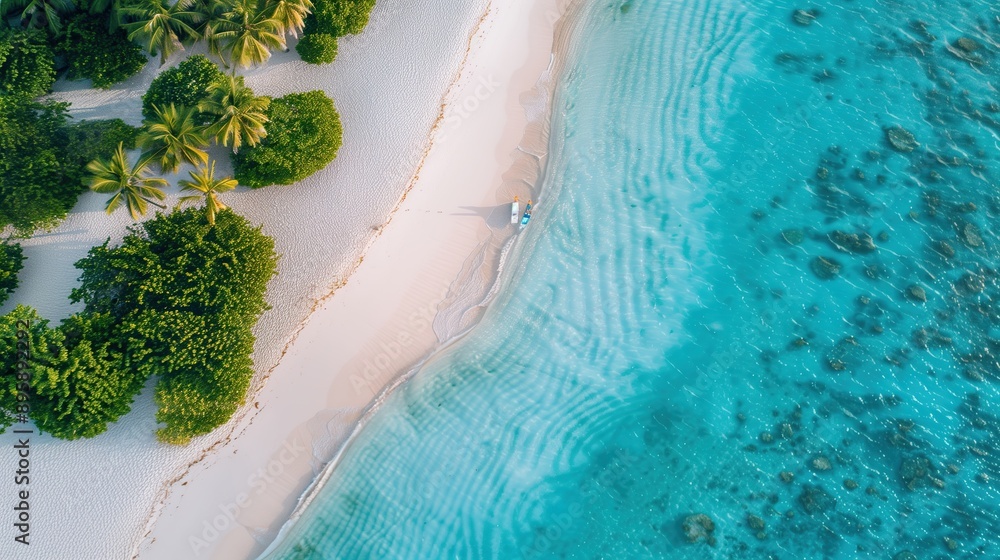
[198,75,271,154]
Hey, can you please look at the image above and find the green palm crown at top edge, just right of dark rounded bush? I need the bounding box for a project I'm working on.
[120,0,204,65]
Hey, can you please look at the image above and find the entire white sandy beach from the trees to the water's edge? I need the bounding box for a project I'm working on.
[0,0,572,560]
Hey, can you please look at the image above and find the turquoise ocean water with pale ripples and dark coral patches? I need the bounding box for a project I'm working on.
[271,0,1000,560]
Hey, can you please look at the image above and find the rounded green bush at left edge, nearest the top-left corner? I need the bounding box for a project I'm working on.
[0,29,56,97]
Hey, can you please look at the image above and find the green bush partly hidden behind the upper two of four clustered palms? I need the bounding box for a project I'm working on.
[142,55,226,119]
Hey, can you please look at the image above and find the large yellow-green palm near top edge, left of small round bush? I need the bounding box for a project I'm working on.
[212,0,285,68]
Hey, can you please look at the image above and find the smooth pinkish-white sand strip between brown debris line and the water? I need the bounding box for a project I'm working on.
[140,0,572,560]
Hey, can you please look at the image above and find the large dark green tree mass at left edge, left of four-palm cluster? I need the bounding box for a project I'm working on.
[0,96,83,233]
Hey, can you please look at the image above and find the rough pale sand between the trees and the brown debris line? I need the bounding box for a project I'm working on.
[0,0,500,560]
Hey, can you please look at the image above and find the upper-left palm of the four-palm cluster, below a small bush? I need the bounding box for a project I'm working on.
[136,103,208,173]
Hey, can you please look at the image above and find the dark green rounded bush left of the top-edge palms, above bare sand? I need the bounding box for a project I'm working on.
[58,14,146,89]
